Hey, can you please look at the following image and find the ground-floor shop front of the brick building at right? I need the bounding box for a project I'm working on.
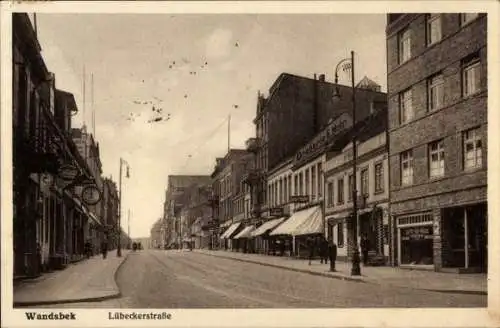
[394,202,488,272]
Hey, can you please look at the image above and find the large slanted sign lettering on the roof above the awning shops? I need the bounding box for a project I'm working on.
[295,113,352,162]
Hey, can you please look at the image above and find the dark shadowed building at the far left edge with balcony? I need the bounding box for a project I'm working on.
[12,13,97,277]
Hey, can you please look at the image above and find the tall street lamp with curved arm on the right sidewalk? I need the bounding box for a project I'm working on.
[333,51,361,276]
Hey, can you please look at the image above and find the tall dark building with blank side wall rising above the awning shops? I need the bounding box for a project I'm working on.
[247,73,386,224]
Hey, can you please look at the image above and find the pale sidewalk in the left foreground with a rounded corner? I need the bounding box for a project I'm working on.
[13,250,129,306]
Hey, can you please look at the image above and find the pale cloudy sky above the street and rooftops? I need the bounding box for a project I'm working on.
[37,14,387,238]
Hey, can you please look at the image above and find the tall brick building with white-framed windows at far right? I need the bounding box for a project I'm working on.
[386,13,488,271]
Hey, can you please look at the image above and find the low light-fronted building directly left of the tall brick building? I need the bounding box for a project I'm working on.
[325,109,391,264]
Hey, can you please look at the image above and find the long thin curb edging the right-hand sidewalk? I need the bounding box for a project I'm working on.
[196,252,488,296]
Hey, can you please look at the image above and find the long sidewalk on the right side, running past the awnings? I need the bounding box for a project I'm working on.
[195,249,488,295]
